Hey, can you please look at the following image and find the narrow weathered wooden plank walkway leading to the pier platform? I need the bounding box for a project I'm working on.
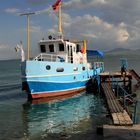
[101,83,133,126]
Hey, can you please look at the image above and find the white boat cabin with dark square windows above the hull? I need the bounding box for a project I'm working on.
[35,39,87,64]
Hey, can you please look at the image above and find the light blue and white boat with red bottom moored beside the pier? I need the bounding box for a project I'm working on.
[18,1,104,99]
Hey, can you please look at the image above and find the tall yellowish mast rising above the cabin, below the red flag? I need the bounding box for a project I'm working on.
[58,5,63,37]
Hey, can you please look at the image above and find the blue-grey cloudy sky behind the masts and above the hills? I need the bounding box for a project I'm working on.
[0,0,140,59]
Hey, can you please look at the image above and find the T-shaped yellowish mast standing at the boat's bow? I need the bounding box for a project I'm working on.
[20,13,35,60]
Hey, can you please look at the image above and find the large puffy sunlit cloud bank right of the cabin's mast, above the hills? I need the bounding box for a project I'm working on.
[49,13,131,49]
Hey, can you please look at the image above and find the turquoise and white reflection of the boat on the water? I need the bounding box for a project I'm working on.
[23,92,106,139]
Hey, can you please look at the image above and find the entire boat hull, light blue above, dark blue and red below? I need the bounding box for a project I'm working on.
[22,61,101,99]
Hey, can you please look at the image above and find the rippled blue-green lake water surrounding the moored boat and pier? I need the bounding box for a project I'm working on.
[0,56,140,140]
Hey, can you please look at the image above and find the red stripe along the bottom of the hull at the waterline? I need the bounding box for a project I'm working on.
[31,87,86,99]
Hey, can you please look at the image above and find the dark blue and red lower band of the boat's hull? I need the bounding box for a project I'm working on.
[23,80,89,99]
